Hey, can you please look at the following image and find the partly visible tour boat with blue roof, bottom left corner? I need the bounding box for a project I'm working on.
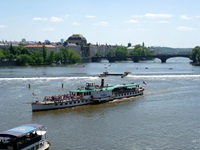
[0,124,50,150]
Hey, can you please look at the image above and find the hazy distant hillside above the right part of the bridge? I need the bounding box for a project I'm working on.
[149,47,193,54]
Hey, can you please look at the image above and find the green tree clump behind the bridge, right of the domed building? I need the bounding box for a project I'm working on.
[107,44,153,61]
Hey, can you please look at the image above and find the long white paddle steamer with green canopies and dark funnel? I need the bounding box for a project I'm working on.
[31,79,144,111]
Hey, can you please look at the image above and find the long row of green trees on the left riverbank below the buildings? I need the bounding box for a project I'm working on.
[0,45,81,65]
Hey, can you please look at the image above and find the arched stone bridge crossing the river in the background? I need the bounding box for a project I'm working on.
[91,54,190,63]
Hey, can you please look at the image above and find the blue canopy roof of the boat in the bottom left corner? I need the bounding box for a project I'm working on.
[0,124,44,138]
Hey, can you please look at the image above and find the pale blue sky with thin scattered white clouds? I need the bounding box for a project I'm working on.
[0,0,200,48]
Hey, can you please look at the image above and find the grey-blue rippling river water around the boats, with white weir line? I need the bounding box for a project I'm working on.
[0,58,200,150]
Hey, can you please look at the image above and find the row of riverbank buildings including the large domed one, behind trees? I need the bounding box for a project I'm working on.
[0,34,117,64]
